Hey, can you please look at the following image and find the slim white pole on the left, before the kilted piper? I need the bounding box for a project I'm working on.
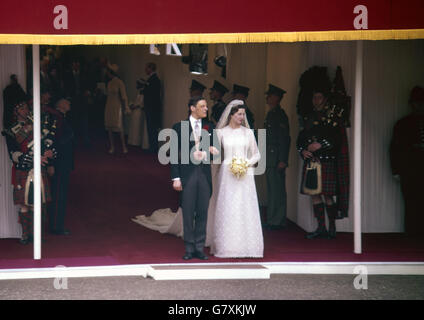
[32,45,41,260]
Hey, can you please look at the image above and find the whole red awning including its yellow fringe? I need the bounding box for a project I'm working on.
[0,0,424,44]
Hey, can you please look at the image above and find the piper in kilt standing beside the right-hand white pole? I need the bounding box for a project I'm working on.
[297,89,349,239]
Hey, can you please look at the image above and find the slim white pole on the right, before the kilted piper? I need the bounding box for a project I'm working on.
[353,40,364,254]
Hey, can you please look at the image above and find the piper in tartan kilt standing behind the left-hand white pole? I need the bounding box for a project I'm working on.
[3,97,55,244]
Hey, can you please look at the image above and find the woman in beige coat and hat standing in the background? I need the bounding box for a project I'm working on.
[105,64,131,154]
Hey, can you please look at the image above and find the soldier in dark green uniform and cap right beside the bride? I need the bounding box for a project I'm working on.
[264,84,290,230]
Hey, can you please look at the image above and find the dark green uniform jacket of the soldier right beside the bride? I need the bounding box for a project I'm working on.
[265,106,291,167]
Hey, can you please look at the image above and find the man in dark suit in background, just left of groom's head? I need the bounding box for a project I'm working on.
[143,62,162,153]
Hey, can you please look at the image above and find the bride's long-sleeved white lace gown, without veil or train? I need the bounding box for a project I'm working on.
[210,126,264,258]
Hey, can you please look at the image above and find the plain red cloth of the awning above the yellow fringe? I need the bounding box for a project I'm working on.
[0,0,424,43]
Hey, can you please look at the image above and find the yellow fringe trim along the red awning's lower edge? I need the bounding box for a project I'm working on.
[0,29,424,45]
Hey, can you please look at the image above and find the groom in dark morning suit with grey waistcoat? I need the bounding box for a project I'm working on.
[171,97,218,260]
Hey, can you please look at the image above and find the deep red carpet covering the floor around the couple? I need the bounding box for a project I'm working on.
[0,132,424,269]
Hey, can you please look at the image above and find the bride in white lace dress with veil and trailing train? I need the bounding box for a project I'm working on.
[133,100,264,258]
